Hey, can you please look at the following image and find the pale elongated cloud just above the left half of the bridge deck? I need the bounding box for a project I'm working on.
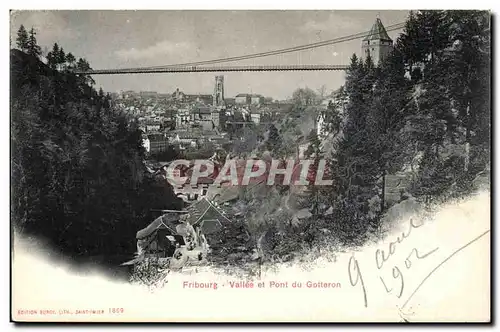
[115,40,193,60]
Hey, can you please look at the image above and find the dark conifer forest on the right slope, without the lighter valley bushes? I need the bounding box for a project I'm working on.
[326,11,491,239]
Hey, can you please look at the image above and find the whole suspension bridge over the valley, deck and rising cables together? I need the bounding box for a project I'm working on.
[74,22,405,75]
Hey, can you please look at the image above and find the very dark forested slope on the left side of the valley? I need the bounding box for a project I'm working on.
[10,26,180,258]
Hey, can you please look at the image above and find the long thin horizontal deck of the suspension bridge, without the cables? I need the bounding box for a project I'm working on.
[74,65,348,75]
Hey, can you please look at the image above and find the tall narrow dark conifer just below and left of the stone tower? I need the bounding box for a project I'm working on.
[330,54,377,229]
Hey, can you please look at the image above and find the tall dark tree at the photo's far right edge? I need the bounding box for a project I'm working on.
[440,11,491,171]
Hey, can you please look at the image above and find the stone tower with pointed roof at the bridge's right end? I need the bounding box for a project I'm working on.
[361,17,392,66]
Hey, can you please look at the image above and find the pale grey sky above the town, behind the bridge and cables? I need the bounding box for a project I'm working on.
[11,10,408,99]
